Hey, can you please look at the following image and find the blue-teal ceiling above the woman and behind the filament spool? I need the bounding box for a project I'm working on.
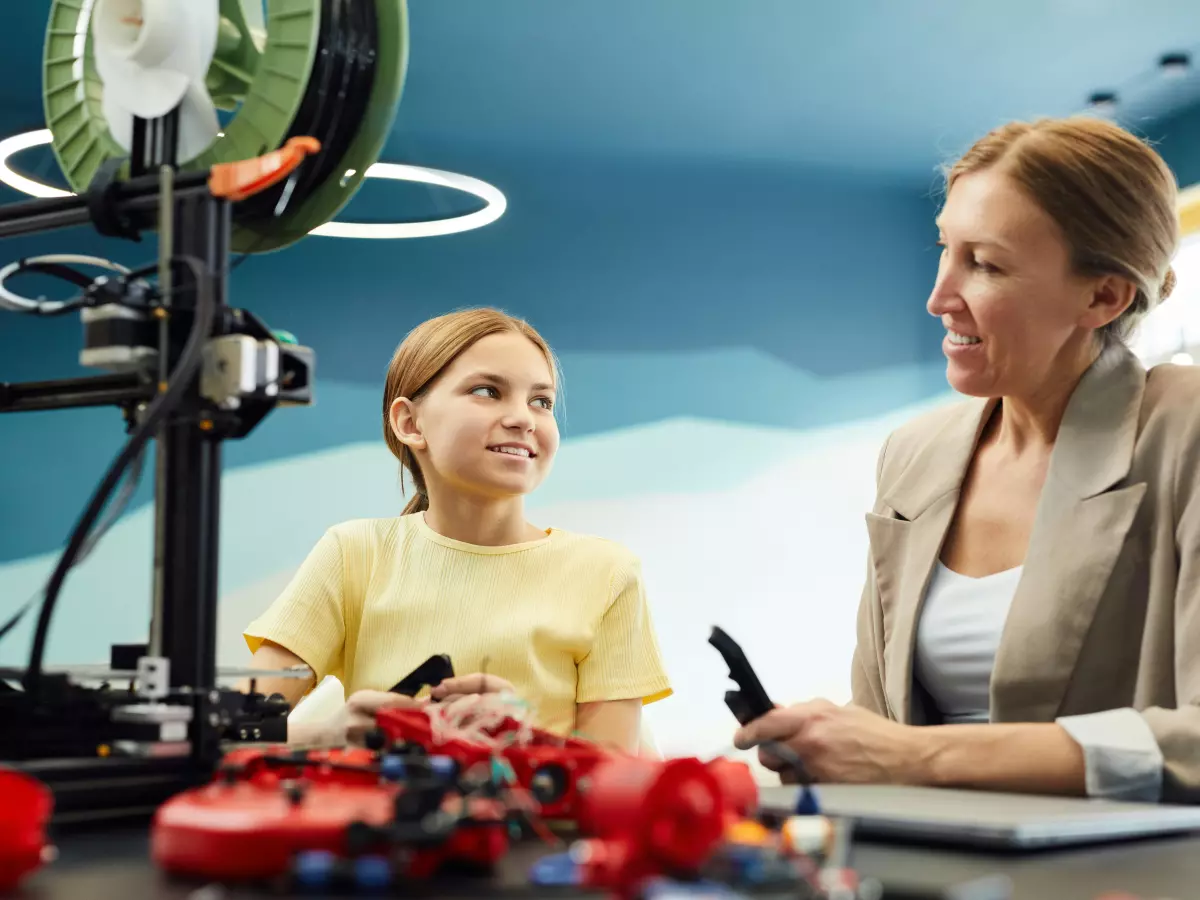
[0,0,1200,175]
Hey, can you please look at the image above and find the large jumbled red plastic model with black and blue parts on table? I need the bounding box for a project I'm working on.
[151,709,757,896]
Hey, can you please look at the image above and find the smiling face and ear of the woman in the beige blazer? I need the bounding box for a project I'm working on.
[926,168,1104,397]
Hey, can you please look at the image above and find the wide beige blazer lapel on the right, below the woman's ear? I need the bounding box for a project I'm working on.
[991,347,1146,721]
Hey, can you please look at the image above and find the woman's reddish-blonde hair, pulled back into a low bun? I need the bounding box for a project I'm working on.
[946,115,1180,343]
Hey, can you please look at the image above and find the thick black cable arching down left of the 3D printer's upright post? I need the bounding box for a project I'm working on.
[25,256,215,694]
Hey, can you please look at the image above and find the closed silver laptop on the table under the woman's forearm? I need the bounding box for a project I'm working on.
[758,785,1200,850]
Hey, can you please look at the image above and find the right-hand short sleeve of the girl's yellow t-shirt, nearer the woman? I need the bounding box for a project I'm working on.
[575,559,672,703]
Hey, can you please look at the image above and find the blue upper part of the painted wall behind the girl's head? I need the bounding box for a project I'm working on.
[0,151,944,566]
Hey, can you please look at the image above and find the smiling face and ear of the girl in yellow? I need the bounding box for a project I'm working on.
[391,332,558,500]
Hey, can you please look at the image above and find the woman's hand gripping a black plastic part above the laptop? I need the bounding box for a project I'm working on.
[733,700,929,784]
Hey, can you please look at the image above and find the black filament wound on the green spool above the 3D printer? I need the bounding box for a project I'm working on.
[233,0,379,229]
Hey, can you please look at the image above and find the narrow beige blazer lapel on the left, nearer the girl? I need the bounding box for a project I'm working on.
[866,400,996,724]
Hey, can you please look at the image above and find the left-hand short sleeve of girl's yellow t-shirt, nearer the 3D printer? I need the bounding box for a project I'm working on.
[244,532,346,684]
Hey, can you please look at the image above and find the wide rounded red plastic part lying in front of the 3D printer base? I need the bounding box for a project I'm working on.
[151,782,400,881]
